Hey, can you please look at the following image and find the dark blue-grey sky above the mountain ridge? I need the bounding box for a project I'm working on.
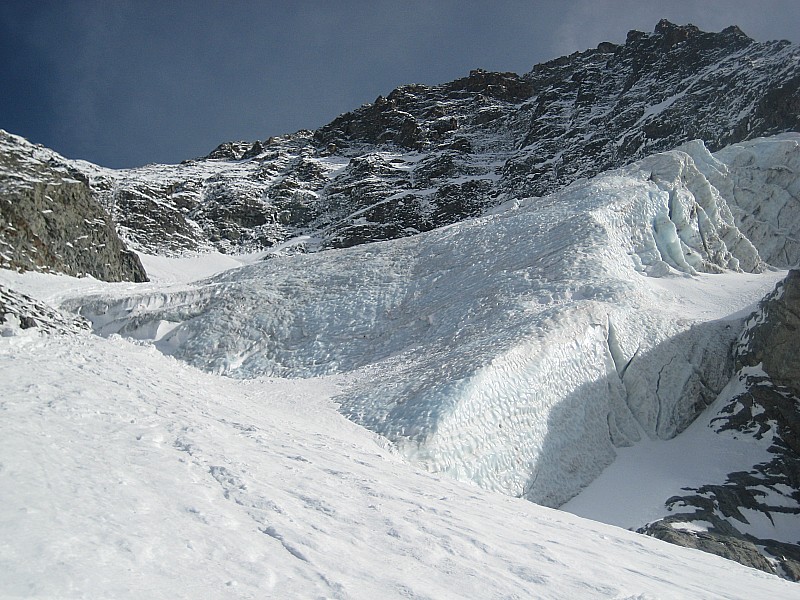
[0,0,800,167]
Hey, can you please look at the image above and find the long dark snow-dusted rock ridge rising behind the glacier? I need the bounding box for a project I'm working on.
[17,21,800,264]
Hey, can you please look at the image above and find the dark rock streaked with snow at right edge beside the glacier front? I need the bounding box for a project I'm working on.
[640,270,800,581]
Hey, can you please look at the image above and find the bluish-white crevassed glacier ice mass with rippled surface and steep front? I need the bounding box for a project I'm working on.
[68,134,800,506]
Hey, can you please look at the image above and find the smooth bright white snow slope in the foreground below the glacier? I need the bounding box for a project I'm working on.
[0,328,797,599]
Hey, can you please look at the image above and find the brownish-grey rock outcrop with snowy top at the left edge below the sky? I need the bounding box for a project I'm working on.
[0,132,147,281]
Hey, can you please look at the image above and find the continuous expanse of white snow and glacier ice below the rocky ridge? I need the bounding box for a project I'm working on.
[0,135,800,598]
